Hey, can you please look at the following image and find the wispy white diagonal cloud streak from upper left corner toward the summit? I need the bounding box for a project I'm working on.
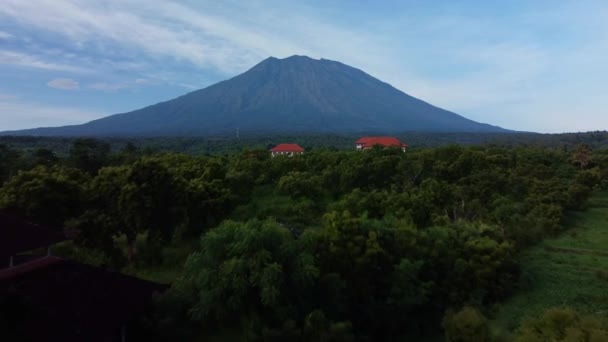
[0,0,247,72]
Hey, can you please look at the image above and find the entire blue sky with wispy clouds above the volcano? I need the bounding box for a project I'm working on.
[0,0,608,132]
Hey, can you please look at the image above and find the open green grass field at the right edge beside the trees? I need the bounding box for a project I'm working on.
[492,192,608,337]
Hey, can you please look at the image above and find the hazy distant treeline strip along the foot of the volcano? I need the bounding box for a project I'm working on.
[0,131,608,156]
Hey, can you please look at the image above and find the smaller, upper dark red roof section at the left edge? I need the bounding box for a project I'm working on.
[0,210,68,257]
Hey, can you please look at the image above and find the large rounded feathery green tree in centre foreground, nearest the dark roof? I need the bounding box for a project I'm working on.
[176,220,319,334]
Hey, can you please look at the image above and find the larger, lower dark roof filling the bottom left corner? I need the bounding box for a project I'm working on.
[0,257,165,342]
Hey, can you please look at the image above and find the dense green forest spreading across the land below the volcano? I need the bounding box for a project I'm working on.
[0,138,608,341]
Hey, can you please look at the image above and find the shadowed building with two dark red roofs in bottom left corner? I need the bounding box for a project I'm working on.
[0,210,167,342]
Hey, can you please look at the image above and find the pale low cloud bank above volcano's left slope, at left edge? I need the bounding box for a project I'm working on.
[0,101,103,131]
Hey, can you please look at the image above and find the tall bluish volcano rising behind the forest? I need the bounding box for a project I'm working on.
[2,56,508,136]
